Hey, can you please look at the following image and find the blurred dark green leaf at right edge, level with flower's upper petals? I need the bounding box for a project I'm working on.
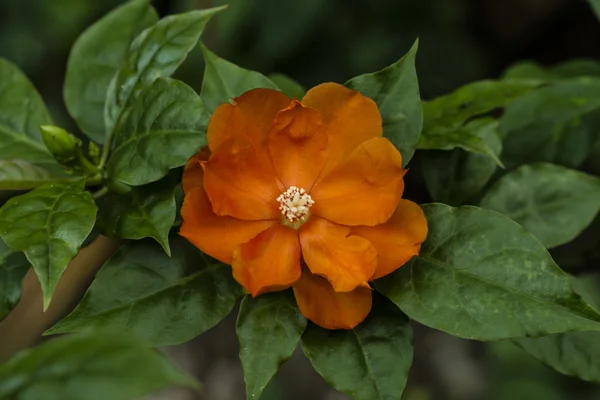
[500,77,600,168]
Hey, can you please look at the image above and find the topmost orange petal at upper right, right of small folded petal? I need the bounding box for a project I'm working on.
[302,83,383,170]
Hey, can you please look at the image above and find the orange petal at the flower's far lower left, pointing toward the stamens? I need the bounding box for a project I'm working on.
[179,186,276,264]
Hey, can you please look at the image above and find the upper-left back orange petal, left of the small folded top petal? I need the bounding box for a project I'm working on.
[206,89,290,153]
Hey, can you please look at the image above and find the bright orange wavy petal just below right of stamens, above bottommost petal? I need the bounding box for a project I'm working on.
[300,217,377,292]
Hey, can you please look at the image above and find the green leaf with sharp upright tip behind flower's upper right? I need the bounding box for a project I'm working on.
[345,41,423,165]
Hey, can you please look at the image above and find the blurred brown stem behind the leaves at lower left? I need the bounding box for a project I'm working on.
[0,236,120,362]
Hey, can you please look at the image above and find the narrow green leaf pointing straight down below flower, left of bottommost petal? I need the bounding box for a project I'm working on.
[237,290,306,399]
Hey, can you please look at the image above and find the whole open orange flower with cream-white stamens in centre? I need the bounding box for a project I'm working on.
[180,83,427,329]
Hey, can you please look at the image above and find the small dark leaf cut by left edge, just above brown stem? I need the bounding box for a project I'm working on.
[0,239,29,321]
